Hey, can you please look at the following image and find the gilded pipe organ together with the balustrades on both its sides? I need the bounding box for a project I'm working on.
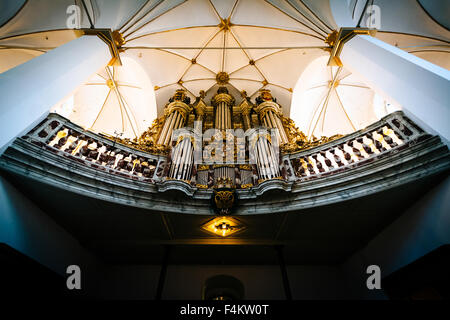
[32,82,414,215]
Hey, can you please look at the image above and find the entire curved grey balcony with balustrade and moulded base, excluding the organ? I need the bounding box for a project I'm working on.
[0,112,450,214]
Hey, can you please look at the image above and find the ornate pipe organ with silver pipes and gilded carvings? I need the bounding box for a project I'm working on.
[116,86,342,192]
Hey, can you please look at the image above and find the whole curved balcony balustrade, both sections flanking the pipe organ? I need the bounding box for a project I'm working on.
[16,112,440,190]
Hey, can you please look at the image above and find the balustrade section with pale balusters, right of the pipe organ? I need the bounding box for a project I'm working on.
[282,111,430,181]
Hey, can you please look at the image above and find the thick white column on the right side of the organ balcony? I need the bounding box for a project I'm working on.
[340,35,450,144]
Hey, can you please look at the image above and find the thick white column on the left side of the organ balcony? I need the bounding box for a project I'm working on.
[0,36,111,153]
